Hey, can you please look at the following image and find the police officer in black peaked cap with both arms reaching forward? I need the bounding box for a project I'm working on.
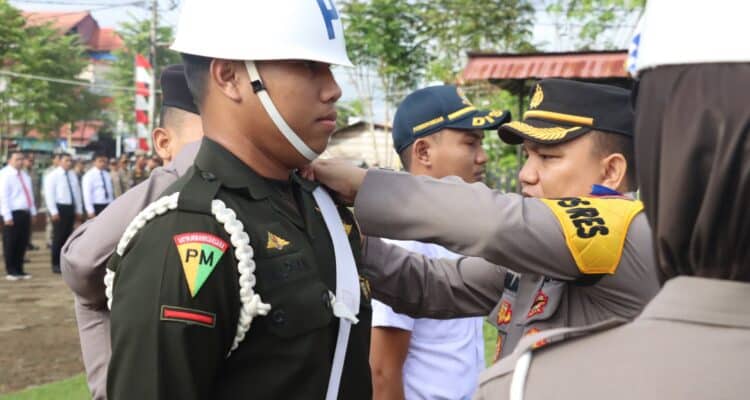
[315,79,659,358]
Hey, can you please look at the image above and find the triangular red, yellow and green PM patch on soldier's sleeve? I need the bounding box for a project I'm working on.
[174,232,229,297]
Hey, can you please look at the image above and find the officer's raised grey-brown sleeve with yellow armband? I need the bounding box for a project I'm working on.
[354,170,658,316]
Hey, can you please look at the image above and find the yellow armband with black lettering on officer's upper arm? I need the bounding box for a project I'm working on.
[541,197,643,275]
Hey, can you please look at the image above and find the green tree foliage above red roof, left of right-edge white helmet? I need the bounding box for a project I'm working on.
[547,0,646,49]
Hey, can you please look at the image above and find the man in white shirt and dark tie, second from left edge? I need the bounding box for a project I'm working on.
[44,154,83,274]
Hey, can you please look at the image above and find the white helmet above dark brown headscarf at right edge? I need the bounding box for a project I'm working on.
[635,0,750,71]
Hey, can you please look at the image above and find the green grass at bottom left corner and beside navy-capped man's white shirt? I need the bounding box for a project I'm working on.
[0,323,497,400]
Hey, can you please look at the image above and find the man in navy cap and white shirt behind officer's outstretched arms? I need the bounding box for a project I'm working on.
[370,86,509,400]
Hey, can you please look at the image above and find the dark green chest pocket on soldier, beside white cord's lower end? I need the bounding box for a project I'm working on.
[266,280,333,338]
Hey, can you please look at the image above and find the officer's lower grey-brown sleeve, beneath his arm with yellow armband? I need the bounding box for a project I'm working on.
[363,237,507,318]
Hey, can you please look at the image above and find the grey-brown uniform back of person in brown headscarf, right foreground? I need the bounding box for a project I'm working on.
[475,277,750,400]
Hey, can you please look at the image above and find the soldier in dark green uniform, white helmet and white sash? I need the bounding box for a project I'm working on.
[105,0,372,400]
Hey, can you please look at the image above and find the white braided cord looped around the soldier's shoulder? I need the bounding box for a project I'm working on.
[104,193,271,357]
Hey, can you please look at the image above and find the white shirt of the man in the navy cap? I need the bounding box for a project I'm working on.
[372,240,485,400]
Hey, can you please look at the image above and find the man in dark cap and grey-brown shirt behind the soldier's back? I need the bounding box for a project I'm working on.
[62,65,203,399]
